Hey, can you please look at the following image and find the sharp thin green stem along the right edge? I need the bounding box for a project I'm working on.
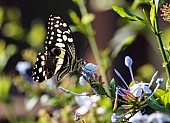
[155,14,170,88]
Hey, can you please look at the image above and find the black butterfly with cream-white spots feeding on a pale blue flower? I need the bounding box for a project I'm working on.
[32,15,83,82]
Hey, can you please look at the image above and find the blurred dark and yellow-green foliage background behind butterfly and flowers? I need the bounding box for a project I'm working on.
[0,0,170,123]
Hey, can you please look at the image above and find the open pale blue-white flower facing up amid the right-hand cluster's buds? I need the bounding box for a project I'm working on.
[130,82,152,97]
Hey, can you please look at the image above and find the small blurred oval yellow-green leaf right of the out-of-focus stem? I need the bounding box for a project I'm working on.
[81,13,95,25]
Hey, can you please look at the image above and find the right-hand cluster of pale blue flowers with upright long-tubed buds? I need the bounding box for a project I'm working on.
[111,56,164,122]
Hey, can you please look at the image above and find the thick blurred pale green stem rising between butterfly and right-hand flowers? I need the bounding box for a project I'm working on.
[78,0,108,90]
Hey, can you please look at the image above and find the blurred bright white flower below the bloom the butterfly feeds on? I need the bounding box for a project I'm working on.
[75,92,100,115]
